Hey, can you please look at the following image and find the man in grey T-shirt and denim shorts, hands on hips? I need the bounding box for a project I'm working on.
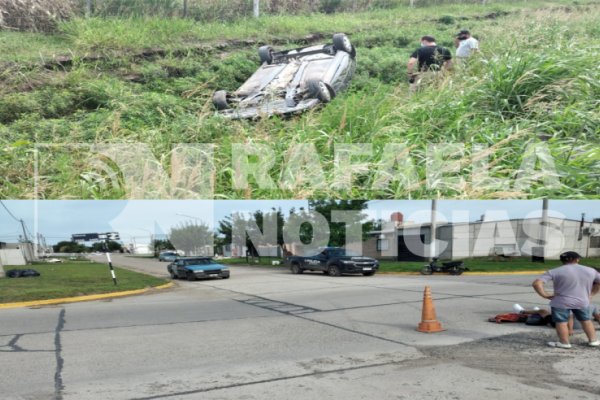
[533,251,600,349]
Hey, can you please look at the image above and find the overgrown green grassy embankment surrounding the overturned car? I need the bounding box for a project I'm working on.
[0,1,600,199]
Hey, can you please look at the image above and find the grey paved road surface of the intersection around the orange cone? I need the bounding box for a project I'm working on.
[0,256,600,400]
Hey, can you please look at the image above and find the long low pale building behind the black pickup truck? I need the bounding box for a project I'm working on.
[363,217,600,261]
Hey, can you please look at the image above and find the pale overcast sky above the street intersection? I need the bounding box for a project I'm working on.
[0,200,600,244]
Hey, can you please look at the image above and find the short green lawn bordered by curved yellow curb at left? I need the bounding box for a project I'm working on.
[0,262,166,303]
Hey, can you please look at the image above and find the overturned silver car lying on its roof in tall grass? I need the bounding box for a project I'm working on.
[213,33,356,119]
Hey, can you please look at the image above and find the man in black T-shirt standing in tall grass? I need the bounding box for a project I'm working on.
[406,36,452,92]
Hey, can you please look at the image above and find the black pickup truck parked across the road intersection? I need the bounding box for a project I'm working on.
[286,247,379,276]
